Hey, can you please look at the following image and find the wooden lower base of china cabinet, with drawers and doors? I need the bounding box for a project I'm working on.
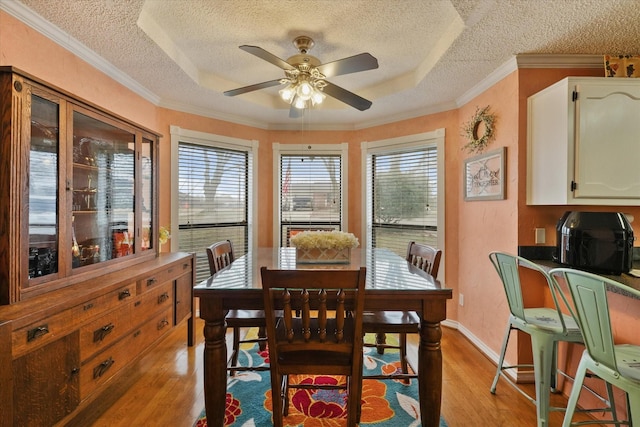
[0,253,195,427]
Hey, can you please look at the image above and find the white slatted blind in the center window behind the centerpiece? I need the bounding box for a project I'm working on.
[280,154,343,246]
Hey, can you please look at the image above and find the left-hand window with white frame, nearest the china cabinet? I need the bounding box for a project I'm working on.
[171,127,254,282]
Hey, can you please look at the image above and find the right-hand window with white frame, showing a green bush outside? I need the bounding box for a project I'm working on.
[363,131,444,257]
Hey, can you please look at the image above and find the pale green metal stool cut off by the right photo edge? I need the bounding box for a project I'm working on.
[549,268,640,427]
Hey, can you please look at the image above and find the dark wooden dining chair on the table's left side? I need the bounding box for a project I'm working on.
[207,240,269,376]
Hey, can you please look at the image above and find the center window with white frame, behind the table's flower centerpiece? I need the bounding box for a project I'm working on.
[274,144,347,246]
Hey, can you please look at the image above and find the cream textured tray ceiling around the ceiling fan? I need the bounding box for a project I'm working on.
[0,0,640,129]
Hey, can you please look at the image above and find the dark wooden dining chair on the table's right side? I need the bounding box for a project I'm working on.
[362,241,442,382]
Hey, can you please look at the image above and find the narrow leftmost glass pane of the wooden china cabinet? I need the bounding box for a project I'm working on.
[29,95,60,279]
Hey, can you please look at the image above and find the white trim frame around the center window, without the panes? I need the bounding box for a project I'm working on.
[272,142,349,245]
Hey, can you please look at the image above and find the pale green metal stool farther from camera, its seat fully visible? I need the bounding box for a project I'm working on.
[489,252,615,427]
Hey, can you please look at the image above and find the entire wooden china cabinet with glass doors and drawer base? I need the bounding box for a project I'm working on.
[0,67,194,426]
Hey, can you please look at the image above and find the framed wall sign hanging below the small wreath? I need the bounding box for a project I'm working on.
[462,147,507,201]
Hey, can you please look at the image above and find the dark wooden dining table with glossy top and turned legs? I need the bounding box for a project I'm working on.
[194,248,452,427]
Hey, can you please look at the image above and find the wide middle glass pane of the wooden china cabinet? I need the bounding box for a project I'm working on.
[72,111,135,268]
